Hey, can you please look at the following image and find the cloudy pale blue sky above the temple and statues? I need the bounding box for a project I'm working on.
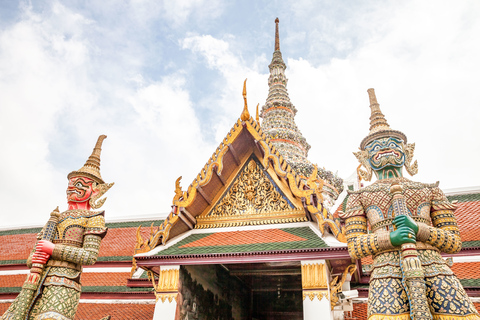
[0,0,480,228]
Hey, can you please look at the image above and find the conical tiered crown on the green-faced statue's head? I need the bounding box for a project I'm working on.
[360,88,407,150]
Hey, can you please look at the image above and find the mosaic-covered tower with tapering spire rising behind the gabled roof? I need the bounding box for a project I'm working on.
[260,18,343,206]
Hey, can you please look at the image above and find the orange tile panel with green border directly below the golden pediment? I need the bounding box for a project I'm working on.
[180,229,307,248]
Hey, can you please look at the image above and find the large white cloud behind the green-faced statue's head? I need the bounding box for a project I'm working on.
[287,2,480,188]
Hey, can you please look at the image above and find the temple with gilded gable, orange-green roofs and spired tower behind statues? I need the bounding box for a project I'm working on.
[0,18,480,320]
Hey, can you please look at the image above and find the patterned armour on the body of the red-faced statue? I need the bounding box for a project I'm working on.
[29,210,107,320]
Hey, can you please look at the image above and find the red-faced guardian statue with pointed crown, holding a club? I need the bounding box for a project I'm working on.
[1,135,113,320]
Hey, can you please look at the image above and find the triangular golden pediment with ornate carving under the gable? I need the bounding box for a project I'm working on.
[196,157,306,228]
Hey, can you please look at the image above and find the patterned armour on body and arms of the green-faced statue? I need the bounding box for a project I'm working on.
[342,178,478,319]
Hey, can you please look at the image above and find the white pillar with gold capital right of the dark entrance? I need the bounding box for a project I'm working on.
[302,260,333,320]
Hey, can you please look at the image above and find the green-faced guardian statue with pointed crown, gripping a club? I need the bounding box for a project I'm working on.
[340,89,480,320]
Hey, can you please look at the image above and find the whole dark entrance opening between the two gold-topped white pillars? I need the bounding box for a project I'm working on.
[177,262,303,320]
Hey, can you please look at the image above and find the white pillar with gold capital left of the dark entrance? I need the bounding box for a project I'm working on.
[153,266,180,320]
